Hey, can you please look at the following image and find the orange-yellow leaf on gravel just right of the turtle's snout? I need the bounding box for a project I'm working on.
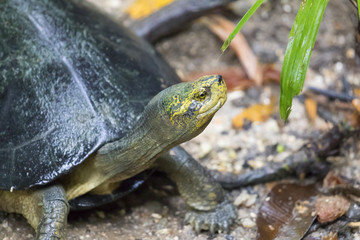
[232,97,276,128]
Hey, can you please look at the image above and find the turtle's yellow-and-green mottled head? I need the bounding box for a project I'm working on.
[152,75,227,142]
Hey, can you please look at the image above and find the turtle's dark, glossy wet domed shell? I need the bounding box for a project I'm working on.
[0,0,179,189]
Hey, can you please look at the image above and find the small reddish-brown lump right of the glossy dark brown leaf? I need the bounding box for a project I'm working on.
[315,195,350,223]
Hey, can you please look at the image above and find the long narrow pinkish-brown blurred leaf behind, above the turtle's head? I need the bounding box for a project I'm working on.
[202,15,263,85]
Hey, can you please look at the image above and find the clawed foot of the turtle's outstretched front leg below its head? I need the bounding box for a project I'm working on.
[185,200,237,234]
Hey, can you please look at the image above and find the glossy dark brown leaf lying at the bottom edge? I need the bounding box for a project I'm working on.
[256,183,317,240]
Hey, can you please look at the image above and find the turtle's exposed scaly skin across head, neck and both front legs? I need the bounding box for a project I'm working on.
[0,76,236,239]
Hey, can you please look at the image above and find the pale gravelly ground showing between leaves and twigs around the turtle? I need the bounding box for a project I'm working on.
[0,0,360,240]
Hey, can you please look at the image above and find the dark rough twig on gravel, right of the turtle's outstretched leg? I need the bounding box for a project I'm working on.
[213,125,356,189]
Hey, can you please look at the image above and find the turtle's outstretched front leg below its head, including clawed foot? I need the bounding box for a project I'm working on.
[157,146,237,233]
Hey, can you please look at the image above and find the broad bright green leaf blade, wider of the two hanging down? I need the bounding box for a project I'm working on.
[280,0,330,120]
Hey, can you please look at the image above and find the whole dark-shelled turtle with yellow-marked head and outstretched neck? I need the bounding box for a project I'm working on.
[0,0,236,239]
